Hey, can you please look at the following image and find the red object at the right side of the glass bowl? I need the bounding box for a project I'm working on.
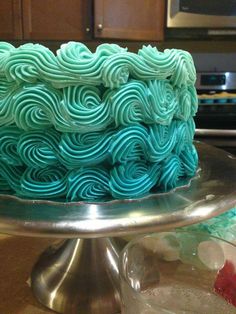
[214,261,236,306]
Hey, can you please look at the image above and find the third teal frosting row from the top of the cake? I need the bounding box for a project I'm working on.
[0,118,195,169]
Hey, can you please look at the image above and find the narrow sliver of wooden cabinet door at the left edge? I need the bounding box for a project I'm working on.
[0,0,22,40]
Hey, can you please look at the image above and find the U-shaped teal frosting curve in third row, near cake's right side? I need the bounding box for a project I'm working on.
[148,121,177,162]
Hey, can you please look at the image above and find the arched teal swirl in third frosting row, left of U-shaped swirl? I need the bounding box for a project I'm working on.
[109,125,148,164]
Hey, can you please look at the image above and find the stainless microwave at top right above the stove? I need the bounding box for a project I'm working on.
[167,0,236,37]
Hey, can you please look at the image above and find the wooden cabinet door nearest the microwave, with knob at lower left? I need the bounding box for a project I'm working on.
[94,0,165,40]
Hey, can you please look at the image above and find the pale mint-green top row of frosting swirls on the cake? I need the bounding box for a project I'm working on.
[0,42,196,89]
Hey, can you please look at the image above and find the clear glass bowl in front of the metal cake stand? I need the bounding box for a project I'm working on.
[119,232,236,314]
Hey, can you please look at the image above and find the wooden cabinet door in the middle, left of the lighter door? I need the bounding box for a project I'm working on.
[23,0,92,40]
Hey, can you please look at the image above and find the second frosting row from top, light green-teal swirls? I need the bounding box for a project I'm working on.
[0,80,198,133]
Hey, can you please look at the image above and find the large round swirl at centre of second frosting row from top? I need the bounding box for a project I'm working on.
[60,86,112,133]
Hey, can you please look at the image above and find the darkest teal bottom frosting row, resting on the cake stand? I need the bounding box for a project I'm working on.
[0,144,198,201]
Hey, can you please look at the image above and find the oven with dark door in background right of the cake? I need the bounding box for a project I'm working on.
[195,72,236,155]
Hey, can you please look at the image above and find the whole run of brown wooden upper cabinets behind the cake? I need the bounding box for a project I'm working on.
[0,0,165,41]
